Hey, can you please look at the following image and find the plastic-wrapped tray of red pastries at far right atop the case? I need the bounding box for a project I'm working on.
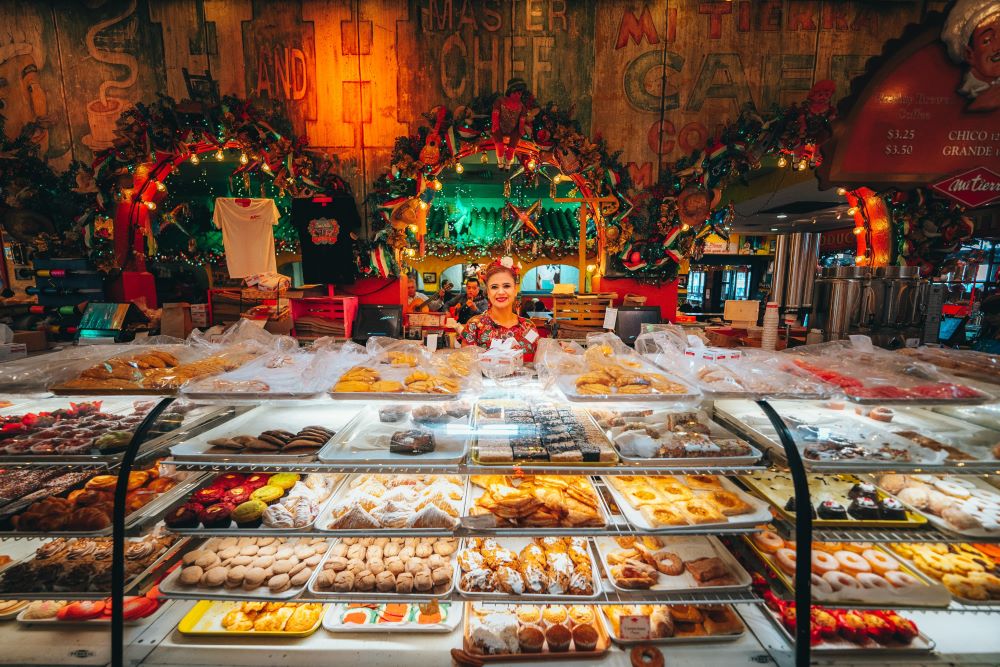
[782,336,995,405]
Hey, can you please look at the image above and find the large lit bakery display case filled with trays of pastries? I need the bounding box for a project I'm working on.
[0,340,1000,665]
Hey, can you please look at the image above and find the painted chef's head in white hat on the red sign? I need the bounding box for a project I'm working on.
[941,0,1000,111]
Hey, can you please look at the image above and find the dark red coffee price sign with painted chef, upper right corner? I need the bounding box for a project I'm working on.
[819,0,1000,190]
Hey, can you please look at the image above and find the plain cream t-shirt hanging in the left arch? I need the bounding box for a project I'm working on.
[213,197,281,278]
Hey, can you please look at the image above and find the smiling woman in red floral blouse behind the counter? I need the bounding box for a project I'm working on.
[462,257,538,361]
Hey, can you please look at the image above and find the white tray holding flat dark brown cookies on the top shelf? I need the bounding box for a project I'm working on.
[170,405,351,466]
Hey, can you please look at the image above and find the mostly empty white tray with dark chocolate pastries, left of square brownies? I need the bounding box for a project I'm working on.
[318,406,473,467]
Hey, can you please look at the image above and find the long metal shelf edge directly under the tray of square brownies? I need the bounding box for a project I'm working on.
[170,460,767,476]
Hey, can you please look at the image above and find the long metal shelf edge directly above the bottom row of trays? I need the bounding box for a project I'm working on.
[160,582,764,605]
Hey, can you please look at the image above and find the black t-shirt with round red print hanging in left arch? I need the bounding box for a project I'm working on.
[292,194,361,285]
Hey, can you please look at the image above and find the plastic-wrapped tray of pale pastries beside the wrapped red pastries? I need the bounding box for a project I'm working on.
[635,326,834,399]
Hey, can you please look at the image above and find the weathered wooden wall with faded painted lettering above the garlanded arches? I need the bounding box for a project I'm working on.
[0,0,941,204]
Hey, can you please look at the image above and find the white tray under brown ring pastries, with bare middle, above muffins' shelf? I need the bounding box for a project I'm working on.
[594,535,752,596]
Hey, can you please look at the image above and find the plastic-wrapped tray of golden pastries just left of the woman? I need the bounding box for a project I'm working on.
[329,338,482,401]
